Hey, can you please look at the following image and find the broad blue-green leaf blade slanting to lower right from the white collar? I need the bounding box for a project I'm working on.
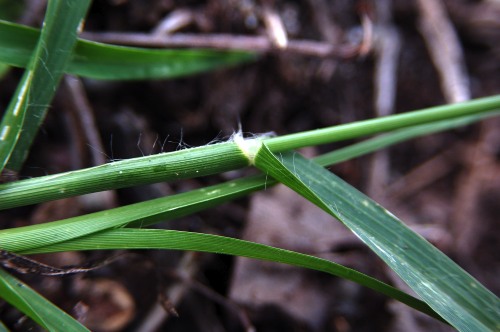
[255,143,500,331]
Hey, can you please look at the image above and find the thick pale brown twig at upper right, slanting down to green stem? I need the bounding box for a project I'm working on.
[417,0,470,103]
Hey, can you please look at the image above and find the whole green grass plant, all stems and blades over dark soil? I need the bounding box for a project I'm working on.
[0,0,500,331]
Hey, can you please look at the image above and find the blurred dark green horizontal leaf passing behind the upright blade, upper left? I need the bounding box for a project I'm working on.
[0,21,256,80]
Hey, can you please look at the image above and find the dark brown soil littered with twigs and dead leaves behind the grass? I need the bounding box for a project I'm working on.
[0,0,500,332]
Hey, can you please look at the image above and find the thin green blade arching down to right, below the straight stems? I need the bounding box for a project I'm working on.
[18,229,439,318]
